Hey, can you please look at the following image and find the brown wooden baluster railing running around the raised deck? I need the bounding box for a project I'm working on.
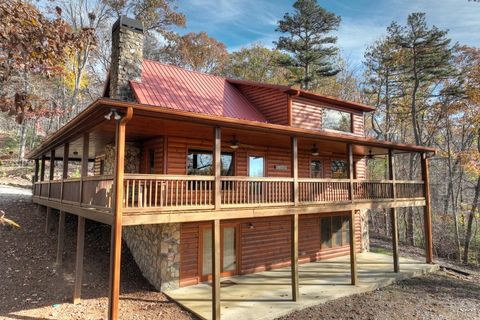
[34,174,424,212]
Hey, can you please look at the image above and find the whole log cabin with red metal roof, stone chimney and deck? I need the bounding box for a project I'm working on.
[29,17,434,319]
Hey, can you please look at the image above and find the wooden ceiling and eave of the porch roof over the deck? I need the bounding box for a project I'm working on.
[28,98,435,159]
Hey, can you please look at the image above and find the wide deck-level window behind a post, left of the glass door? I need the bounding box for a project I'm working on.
[187,150,233,176]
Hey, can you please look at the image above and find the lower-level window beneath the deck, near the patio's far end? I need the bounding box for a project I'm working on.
[320,215,350,248]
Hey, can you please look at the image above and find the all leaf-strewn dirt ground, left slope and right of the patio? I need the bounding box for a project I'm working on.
[0,186,480,320]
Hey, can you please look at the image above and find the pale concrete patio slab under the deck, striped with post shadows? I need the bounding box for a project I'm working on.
[166,252,438,320]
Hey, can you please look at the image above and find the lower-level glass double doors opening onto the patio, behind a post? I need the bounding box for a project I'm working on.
[199,224,238,281]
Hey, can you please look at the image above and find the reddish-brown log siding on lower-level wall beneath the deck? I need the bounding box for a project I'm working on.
[180,212,361,287]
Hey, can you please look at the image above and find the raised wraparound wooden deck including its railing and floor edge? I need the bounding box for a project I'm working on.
[33,174,425,225]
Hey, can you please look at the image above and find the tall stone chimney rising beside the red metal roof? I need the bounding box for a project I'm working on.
[109,16,143,101]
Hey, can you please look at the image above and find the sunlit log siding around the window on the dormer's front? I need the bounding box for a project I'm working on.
[292,98,365,136]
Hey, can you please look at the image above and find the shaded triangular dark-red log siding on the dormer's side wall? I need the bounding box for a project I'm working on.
[236,85,288,125]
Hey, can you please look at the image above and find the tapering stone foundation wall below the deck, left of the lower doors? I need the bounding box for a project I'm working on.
[123,223,180,291]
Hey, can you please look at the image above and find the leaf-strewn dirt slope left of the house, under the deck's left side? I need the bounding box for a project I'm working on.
[0,186,197,320]
